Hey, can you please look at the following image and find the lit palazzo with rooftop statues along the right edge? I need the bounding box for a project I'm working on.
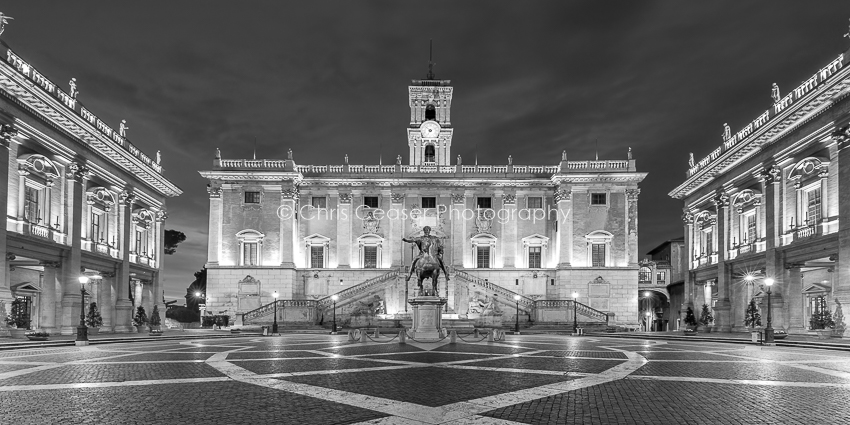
[670,44,850,333]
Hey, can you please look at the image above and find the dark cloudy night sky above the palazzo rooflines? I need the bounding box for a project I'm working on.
[0,0,850,299]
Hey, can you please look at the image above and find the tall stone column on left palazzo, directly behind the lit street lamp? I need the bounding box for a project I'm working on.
[61,162,90,335]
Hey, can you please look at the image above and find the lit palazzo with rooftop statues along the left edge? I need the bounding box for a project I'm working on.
[0,38,181,334]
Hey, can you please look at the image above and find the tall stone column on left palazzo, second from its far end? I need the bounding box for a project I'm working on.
[112,187,136,333]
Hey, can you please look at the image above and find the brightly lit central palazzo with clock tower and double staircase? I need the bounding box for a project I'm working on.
[200,67,646,323]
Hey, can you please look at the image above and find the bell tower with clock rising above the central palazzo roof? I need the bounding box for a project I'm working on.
[407,42,453,166]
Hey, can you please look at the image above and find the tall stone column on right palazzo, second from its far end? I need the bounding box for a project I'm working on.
[714,193,734,332]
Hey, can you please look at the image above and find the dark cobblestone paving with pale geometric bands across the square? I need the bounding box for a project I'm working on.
[0,334,850,425]
